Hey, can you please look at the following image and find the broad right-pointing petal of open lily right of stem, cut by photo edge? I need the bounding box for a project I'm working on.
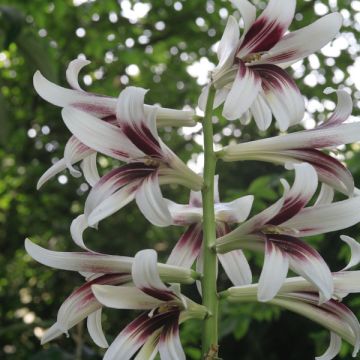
[282,197,360,237]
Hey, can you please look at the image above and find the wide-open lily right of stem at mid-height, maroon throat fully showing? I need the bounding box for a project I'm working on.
[216,163,360,302]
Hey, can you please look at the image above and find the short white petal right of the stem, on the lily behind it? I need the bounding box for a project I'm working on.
[215,195,254,224]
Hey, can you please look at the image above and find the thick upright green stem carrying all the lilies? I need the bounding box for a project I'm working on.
[202,87,218,360]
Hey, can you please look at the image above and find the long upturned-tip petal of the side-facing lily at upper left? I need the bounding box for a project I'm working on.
[33,71,116,117]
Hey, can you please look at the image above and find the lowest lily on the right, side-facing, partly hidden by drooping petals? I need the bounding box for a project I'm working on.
[222,235,360,360]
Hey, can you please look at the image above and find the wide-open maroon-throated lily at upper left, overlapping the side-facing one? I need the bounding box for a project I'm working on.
[62,87,203,248]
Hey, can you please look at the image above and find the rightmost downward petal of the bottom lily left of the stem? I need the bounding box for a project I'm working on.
[159,323,186,360]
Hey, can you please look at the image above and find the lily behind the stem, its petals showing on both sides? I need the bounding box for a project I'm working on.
[165,176,254,285]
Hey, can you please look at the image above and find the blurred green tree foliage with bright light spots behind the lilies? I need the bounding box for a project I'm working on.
[0,0,360,360]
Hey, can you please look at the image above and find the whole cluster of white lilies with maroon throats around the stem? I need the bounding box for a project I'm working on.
[25,0,360,360]
